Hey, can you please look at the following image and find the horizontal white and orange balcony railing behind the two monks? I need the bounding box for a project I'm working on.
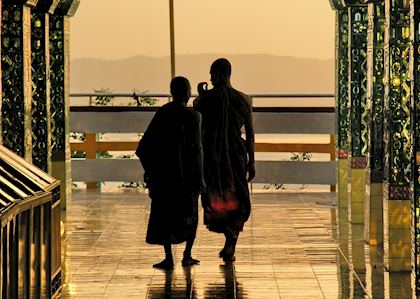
[70,93,336,187]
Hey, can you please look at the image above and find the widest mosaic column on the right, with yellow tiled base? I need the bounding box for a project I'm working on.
[384,0,413,272]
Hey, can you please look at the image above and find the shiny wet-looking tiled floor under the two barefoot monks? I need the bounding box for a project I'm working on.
[62,189,412,299]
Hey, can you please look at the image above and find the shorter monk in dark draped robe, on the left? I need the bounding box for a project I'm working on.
[136,77,205,270]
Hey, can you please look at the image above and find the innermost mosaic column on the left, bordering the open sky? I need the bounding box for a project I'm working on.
[50,0,80,209]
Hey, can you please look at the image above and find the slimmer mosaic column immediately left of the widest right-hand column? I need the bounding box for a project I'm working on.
[365,0,385,245]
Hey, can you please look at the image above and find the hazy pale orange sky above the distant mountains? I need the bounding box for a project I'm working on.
[71,0,335,59]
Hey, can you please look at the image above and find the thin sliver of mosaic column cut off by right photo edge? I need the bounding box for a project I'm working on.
[410,0,420,296]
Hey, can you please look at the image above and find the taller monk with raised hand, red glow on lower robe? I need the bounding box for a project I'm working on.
[194,58,255,261]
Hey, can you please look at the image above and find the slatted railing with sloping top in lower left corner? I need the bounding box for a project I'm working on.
[0,146,62,298]
